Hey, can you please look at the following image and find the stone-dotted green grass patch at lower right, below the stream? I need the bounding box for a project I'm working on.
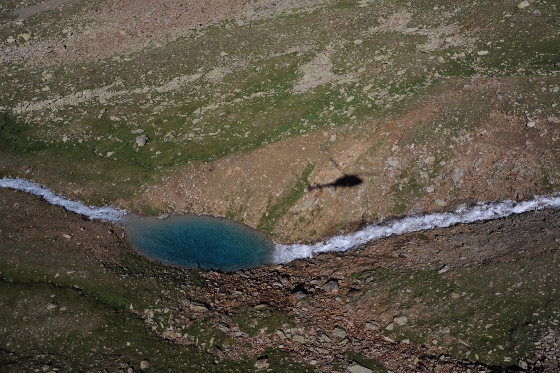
[353,248,560,366]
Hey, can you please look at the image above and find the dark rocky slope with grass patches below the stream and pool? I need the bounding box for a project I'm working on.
[0,179,560,372]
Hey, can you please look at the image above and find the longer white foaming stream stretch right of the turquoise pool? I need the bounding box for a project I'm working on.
[272,193,560,263]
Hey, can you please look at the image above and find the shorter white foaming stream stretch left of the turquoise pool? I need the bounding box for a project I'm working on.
[0,178,125,222]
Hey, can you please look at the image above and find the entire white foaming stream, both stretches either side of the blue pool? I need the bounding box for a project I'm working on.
[0,178,560,264]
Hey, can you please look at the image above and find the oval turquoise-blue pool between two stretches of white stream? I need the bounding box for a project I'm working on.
[122,215,274,272]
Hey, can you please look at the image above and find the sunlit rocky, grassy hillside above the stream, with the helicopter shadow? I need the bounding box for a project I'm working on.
[0,0,560,243]
